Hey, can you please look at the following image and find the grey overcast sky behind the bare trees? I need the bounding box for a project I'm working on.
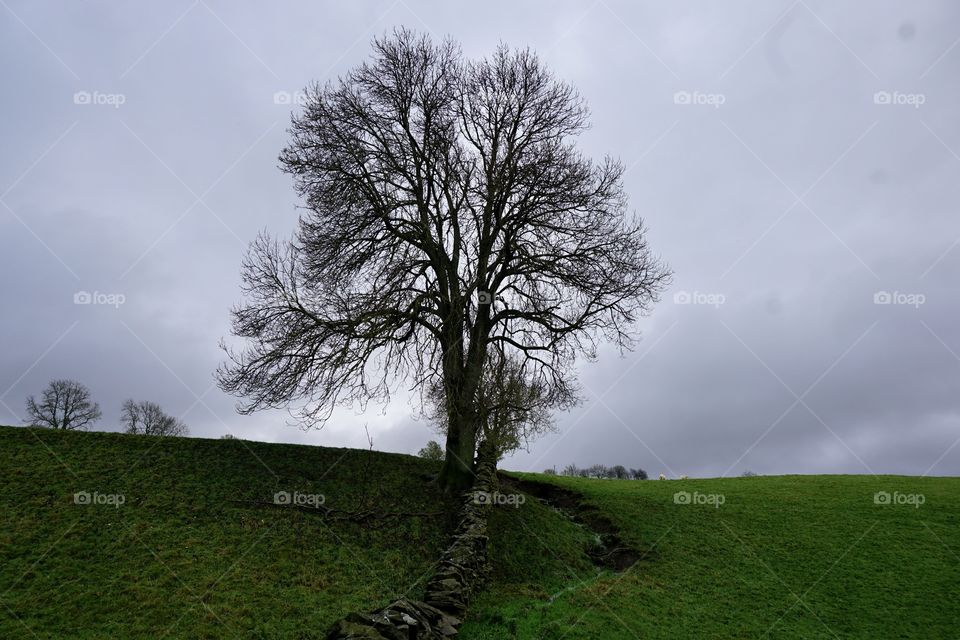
[0,0,960,476]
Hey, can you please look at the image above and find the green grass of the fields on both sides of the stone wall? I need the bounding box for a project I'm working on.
[0,427,960,640]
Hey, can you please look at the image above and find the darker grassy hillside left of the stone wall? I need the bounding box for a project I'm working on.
[0,427,584,639]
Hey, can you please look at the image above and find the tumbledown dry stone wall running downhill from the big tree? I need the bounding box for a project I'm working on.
[327,442,498,640]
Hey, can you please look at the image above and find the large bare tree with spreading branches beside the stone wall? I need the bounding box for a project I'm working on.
[218,30,668,490]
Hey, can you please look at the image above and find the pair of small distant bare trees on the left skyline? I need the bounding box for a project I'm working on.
[27,379,189,436]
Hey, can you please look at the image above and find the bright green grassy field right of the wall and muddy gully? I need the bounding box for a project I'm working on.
[463,474,960,639]
